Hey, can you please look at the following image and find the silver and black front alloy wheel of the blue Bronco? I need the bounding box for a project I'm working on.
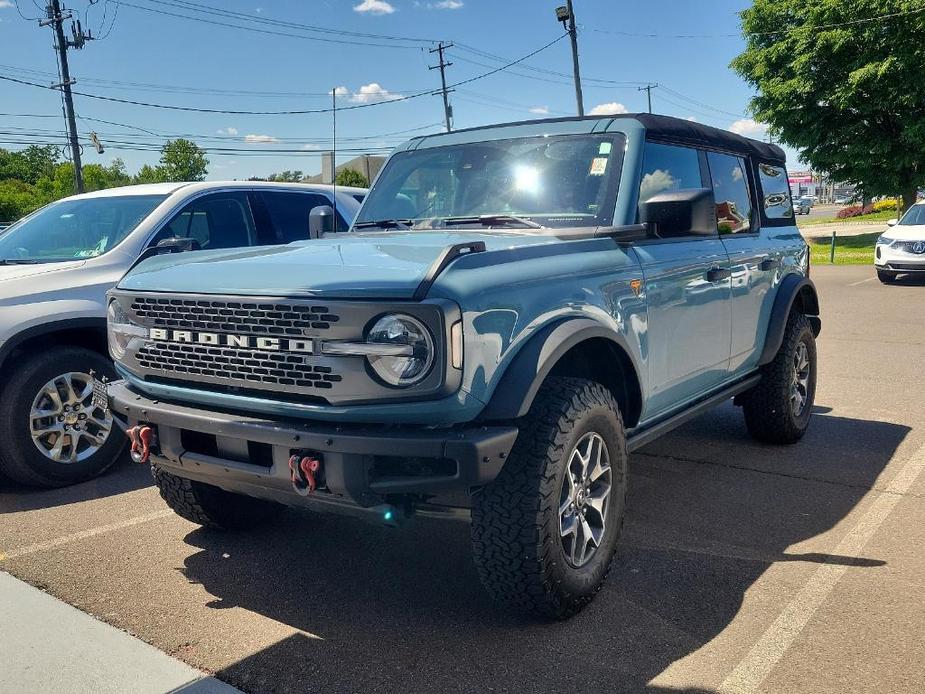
[559,431,613,568]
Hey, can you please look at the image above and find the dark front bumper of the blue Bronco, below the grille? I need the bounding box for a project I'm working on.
[109,381,518,507]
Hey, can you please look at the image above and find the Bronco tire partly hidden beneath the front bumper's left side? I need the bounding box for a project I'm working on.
[151,465,284,530]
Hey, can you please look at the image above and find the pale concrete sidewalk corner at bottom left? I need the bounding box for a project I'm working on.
[0,572,238,694]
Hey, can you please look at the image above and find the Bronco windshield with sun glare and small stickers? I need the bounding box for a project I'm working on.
[356,134,624,230]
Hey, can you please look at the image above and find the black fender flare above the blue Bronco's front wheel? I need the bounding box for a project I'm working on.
[479,318,638,421]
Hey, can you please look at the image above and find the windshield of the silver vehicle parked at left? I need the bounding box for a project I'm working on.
[0,195,167,263]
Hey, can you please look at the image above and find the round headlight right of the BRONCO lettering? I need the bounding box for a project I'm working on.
[366,313,434,387]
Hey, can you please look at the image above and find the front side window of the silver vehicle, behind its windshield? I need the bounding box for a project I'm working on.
[152,193,255,249]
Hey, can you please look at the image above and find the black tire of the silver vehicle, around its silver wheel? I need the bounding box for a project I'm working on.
[0,347,127,488]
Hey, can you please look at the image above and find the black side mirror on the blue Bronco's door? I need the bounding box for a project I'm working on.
[639,188,717,239]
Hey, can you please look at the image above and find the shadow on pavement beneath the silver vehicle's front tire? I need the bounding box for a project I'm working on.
[0,455,153,514]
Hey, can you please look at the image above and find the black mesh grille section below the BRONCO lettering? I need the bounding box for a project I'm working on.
[136,343,341,389]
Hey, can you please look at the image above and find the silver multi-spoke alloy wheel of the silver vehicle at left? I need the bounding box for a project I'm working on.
[29,372,112,464]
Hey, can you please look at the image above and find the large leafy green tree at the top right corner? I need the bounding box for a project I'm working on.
[732,0,925,212]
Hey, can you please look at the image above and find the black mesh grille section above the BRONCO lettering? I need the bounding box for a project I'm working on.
[132,297,340,336]
